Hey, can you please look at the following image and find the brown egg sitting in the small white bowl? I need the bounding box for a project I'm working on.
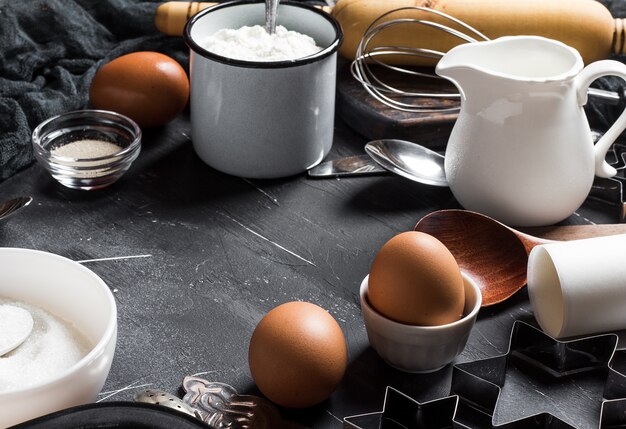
[367,231,465,326]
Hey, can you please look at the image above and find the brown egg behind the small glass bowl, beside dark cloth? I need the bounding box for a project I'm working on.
[89,52,189,127]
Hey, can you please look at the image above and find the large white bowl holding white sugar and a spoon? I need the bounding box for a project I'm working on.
[0,248,117,428]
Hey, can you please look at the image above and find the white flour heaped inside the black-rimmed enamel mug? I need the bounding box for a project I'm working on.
[201,25,322,62]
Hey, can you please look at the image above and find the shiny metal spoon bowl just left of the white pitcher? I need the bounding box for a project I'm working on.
[365,139,448,186]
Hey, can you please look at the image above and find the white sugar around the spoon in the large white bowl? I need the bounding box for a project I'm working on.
[0,297,92,393]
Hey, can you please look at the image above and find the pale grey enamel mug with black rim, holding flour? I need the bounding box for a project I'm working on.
[184,2,343,179]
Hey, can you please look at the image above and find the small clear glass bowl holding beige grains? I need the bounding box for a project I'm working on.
[32,110,141,190]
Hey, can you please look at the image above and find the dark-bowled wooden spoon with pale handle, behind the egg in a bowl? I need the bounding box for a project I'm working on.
[415,210,626,307]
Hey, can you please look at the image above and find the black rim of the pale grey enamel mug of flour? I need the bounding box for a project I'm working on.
[183,0,343,69]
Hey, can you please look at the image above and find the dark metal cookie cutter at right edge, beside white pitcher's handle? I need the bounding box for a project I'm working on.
[589,143,626,222]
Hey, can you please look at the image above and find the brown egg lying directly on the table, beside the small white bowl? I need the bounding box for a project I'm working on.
[248,302,348,408]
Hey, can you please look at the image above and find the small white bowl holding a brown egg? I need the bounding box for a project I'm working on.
[360,273,482,373]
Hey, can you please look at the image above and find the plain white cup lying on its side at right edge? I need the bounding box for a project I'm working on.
[528,234,626,338]
